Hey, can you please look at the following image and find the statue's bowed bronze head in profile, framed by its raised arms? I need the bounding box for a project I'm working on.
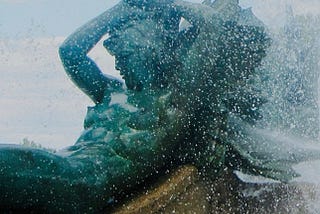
[104,20,172,90]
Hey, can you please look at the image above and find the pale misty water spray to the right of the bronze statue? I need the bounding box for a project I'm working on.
[231,7,320,213]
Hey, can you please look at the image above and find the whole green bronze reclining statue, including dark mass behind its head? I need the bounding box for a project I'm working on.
[0,0,312,212]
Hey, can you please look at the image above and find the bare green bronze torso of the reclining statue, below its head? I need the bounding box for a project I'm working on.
[64,89,188,185]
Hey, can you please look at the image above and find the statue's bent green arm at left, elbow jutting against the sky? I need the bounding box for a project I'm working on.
[59,2,148,103]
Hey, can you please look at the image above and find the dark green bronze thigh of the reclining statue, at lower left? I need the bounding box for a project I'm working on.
[0,145,99,213]
